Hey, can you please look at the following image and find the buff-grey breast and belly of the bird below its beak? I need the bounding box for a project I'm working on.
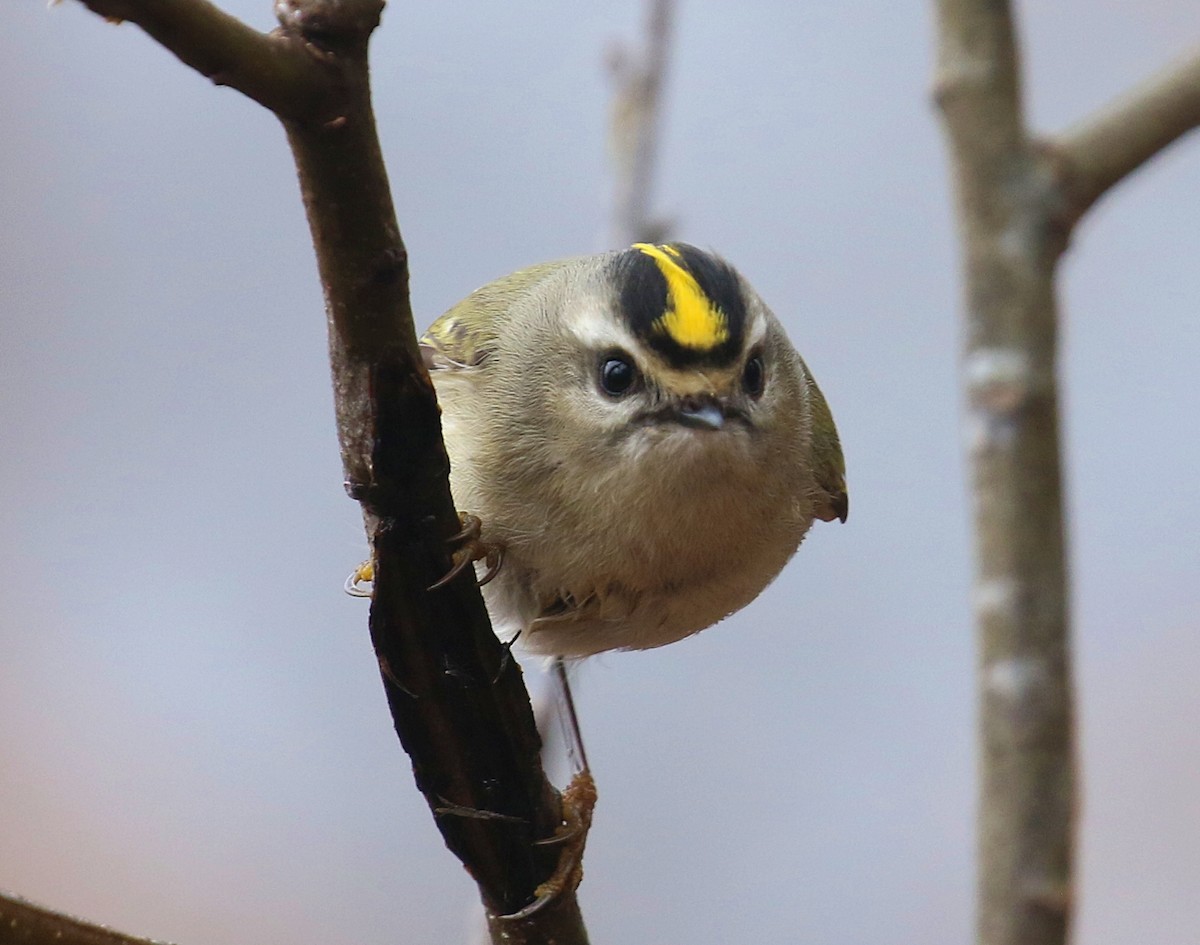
[446,408,812,656]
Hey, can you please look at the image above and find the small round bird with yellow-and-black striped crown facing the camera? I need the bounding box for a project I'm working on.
[421,243,848,656]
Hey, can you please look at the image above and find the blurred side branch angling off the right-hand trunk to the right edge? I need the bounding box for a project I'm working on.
[1048,50,1200,223]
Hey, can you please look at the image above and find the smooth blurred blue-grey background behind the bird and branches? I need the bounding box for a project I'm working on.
[0,0,1200,945]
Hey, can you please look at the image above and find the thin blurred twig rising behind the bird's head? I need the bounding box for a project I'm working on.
[608,0,673,248]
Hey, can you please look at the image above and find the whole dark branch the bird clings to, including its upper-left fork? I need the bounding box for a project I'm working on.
[49,0,587,945]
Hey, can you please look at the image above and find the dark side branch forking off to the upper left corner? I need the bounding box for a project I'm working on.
[80,0,328,116]
